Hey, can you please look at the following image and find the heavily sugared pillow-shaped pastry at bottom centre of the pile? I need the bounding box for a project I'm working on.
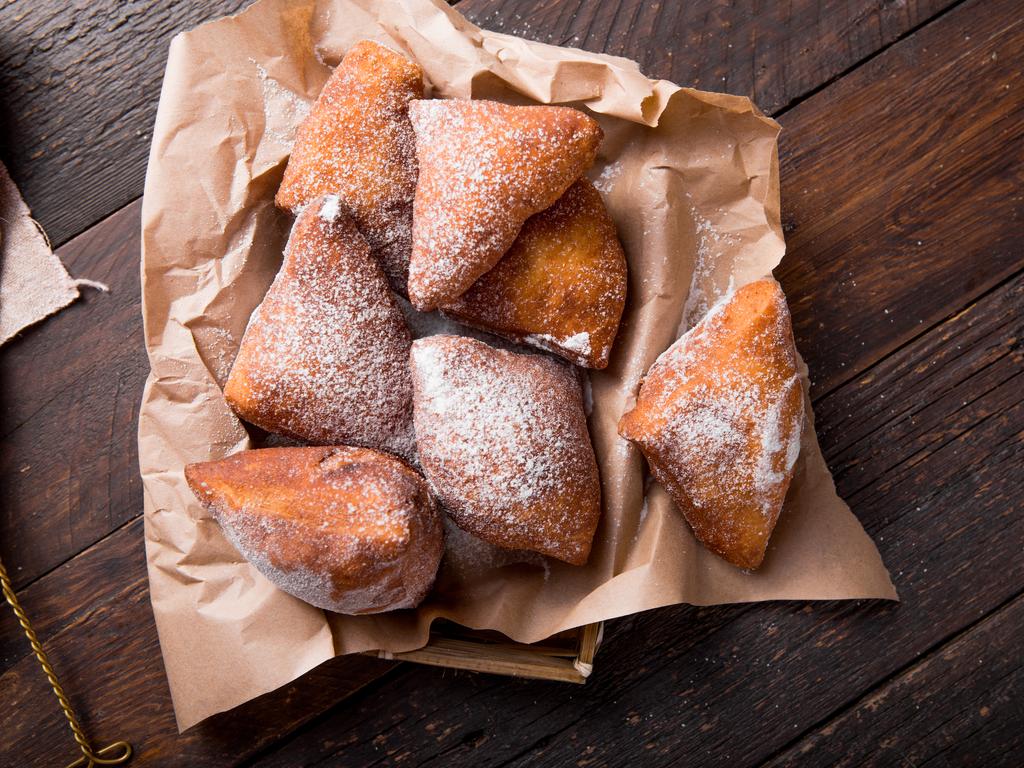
[412,336,601,565]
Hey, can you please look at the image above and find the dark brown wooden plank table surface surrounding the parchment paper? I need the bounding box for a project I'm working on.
[0,0,1024,768]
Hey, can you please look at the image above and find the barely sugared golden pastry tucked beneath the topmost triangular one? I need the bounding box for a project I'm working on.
[441,178,626,368]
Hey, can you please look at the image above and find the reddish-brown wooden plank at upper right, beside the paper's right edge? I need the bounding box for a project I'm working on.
[777,0,1024,394]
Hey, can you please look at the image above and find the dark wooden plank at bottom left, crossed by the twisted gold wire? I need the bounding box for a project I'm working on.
[0,519,394,768]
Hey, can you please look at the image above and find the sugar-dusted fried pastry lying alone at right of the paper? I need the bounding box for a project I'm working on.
[618,278,804,568]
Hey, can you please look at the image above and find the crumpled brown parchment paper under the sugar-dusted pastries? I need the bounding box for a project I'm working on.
[139,0,895,728]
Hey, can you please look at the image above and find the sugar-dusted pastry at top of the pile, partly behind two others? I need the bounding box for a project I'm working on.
[276,40,423,294]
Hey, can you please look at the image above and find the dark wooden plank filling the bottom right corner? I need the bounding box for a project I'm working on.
[769,598,1024,768]
